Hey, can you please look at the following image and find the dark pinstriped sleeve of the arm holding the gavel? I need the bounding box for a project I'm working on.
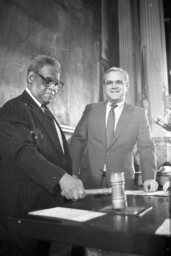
[0,101,65,193]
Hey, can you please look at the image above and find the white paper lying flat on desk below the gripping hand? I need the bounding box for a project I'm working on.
[29,207,107,222]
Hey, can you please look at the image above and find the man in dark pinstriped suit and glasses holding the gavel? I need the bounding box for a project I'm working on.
[0,55,84,256]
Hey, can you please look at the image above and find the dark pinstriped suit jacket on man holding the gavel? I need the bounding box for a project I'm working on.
[0,91,71,226]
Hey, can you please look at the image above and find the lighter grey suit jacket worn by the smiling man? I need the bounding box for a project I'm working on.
[70,102,156,188]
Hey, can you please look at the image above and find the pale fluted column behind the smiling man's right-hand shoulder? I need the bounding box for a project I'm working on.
[118,0,171,165]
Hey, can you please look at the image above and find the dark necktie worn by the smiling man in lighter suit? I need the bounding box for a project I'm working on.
[106,104,117,148]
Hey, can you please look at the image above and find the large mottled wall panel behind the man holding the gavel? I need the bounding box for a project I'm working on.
[0,0,101,126]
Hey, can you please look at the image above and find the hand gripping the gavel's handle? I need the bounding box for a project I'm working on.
[59,173,85,200]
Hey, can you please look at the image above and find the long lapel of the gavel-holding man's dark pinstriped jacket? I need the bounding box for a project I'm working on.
[20,91,63,154]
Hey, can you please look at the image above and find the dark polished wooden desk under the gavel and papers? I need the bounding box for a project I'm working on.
[8,196,171,256]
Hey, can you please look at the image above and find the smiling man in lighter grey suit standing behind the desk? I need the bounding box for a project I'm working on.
[70,68,157,191]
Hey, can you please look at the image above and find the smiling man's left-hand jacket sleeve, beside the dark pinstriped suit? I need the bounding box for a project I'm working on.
[69,105,90,175]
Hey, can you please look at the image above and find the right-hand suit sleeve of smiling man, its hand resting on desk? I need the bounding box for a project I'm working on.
[137,110,156,180]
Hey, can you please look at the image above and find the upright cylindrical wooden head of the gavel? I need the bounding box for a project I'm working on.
[110,172,127,209]
